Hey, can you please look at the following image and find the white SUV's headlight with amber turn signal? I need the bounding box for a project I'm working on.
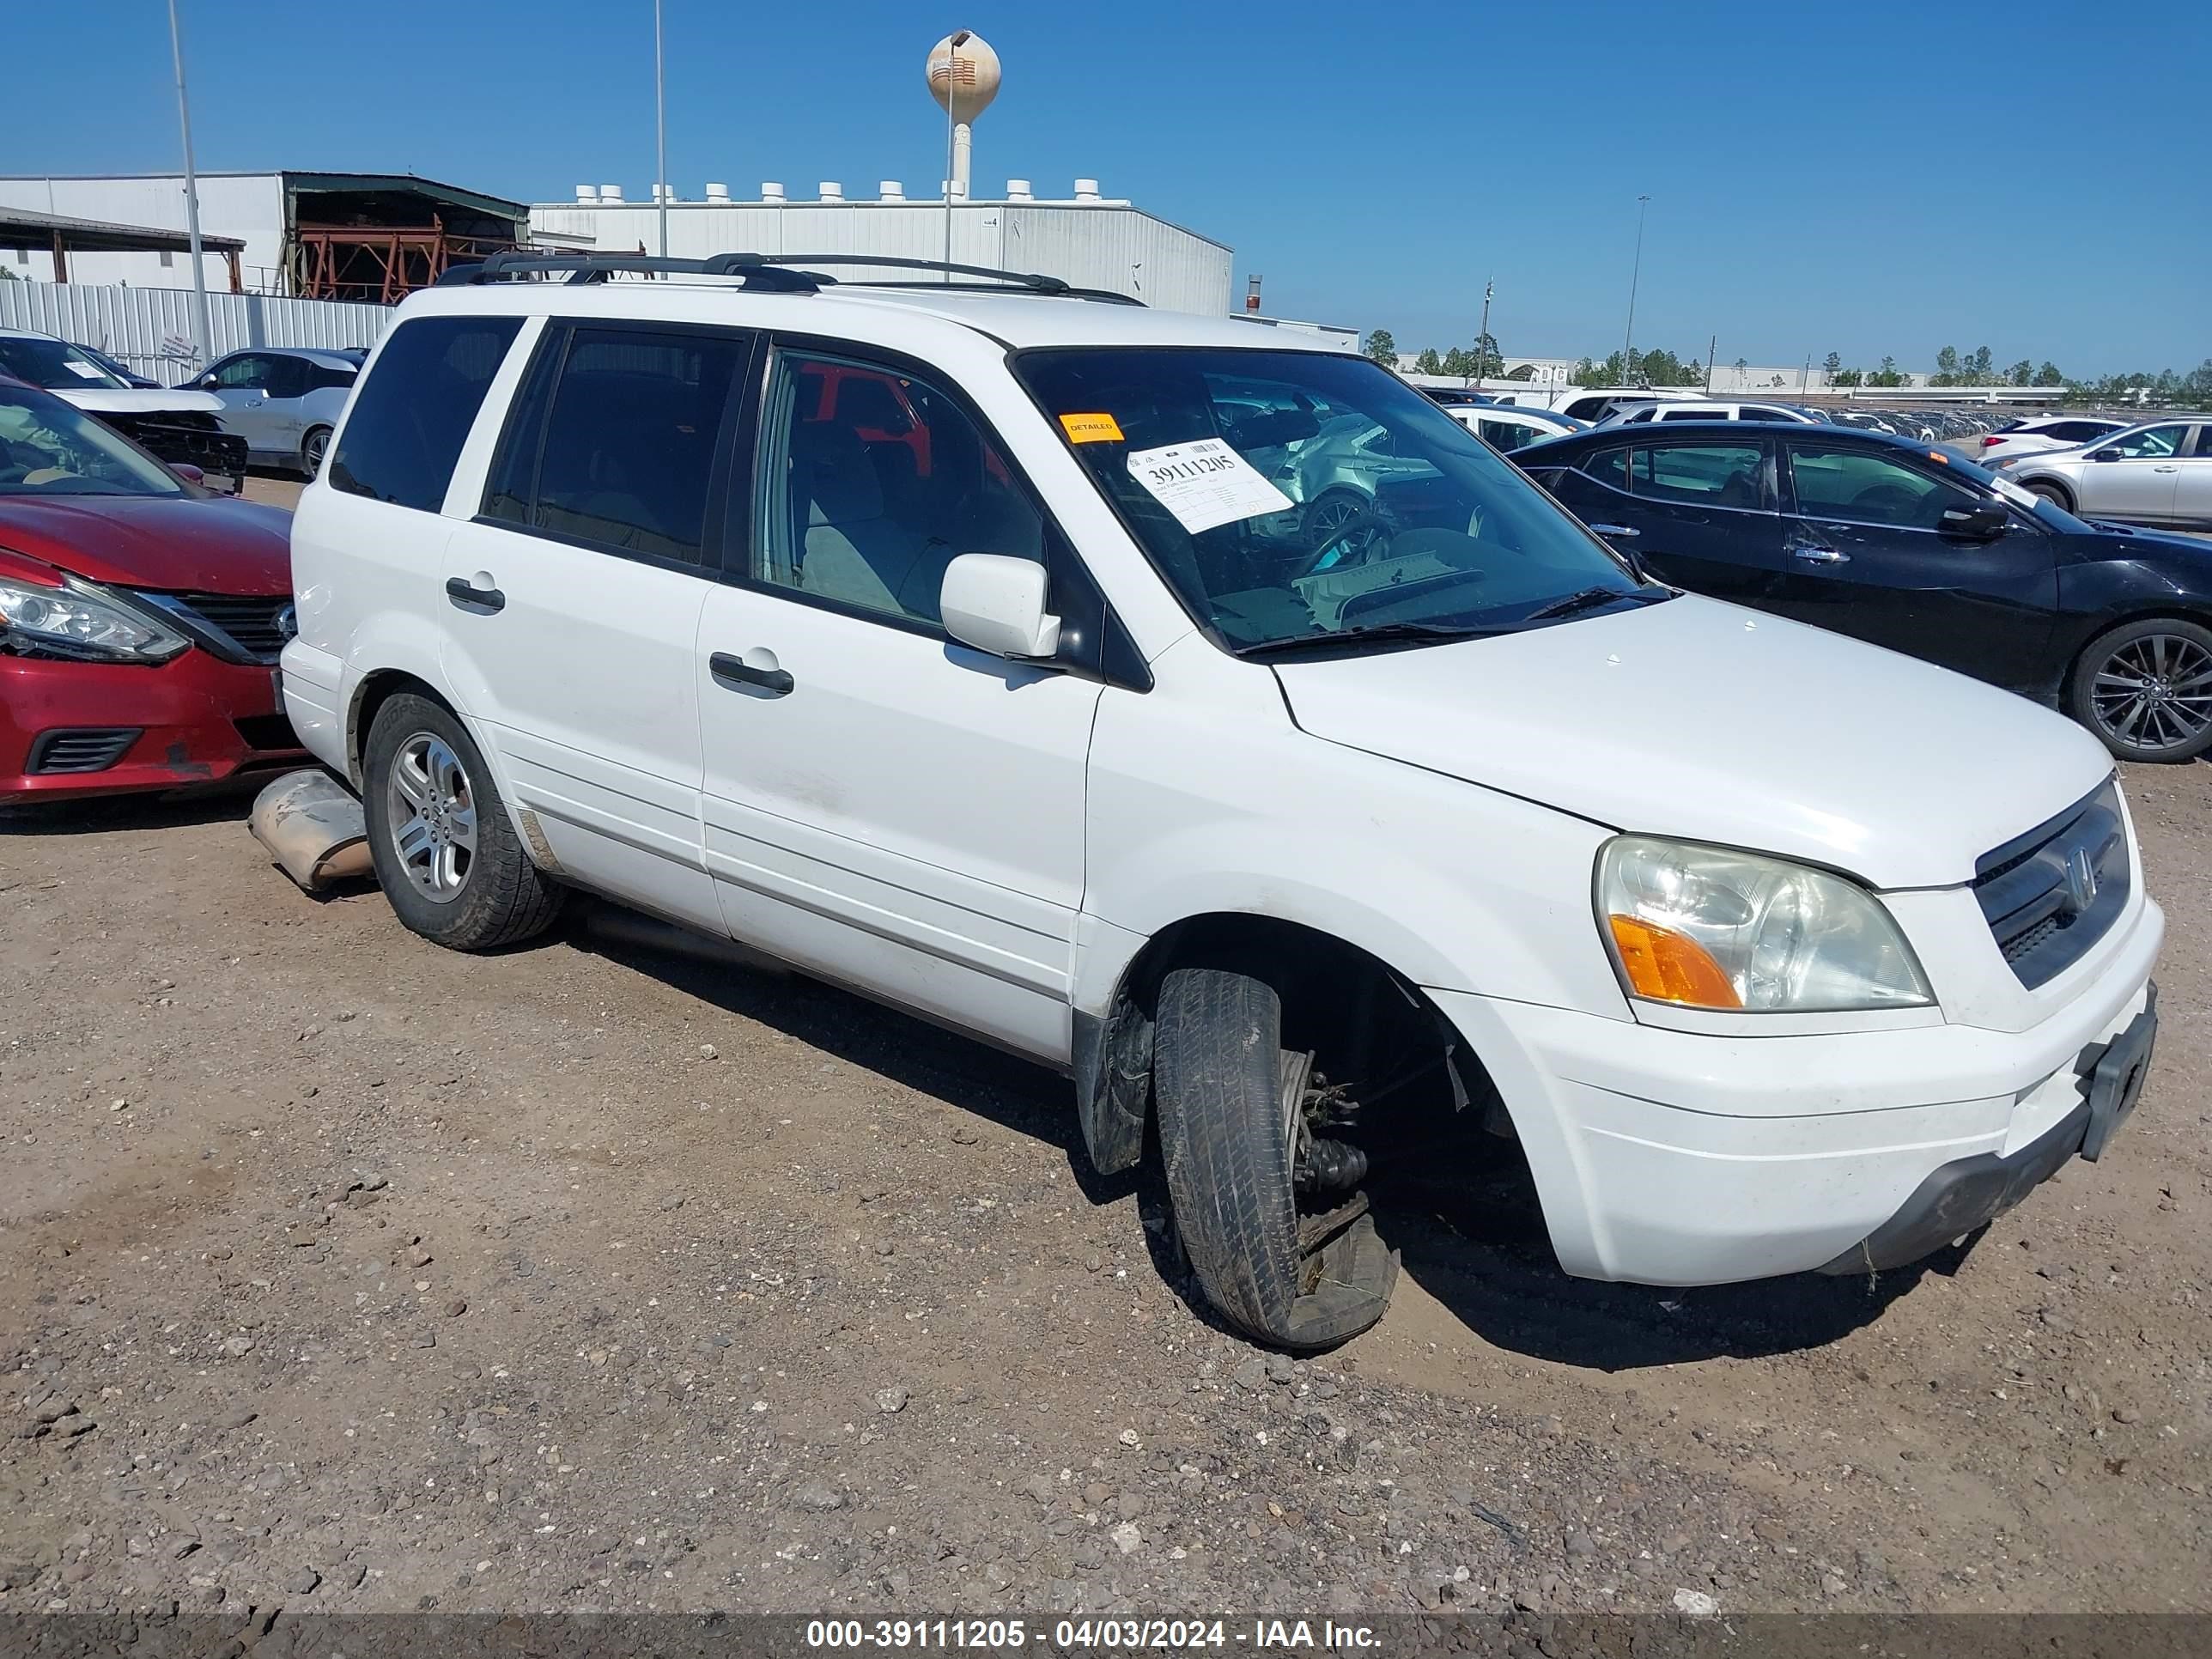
[1597,836,1936,1013]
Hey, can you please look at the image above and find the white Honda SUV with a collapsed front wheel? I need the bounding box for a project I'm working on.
[283,254,2163,1349]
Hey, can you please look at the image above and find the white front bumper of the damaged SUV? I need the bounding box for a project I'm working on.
[1431,900,2166,1285]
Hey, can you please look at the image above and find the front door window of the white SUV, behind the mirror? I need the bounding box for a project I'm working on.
[752,352,1046,629]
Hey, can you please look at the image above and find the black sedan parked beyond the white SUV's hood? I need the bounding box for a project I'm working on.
[1510,420,2212,761]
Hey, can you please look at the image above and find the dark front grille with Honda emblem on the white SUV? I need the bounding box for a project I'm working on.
[1973,781,2135,991]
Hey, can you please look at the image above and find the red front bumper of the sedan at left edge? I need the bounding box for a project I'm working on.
[0,646,303,803]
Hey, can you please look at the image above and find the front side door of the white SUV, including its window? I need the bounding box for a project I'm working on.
[692,352,1102,1060]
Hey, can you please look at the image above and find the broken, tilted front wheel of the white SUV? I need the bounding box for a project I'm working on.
[1152,969,1398,1349]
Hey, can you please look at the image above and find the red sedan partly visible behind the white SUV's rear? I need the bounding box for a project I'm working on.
[0,378,305,805]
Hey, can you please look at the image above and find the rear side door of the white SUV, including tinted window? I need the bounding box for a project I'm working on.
[442,323,757,931]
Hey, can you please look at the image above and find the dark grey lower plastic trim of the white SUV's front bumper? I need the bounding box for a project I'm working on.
[1820,987,2159,1274]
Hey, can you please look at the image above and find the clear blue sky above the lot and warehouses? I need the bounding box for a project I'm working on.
[17,0,2212,374]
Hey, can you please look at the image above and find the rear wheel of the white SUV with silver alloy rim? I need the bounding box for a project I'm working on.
[361,692,562,951]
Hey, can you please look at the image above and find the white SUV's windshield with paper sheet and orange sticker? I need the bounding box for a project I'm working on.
[1015,347,1670,650]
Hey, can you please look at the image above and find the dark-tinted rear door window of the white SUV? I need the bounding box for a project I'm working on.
[484,327,752,566]
